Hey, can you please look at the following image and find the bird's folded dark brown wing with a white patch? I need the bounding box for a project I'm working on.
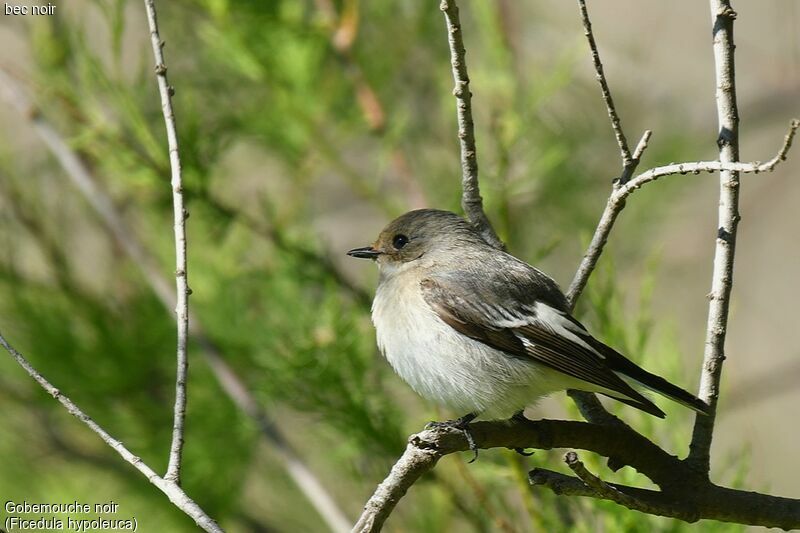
[421,267,664,418]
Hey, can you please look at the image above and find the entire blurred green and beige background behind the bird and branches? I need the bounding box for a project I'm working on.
[0,0,800,532]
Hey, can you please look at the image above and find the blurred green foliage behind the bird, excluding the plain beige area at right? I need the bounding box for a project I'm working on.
[0,0,741,532]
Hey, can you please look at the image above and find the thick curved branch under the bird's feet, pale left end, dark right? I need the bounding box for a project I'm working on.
[354,419,800,532]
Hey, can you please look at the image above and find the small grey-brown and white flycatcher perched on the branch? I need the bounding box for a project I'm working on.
[347,209,708,451]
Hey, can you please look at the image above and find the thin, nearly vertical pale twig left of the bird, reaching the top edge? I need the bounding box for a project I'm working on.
[144,0,189,485]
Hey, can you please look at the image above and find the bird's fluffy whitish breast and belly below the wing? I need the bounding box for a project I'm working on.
[372,271,570,417]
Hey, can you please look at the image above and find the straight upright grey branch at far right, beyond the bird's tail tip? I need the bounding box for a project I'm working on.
[687,0,740,475]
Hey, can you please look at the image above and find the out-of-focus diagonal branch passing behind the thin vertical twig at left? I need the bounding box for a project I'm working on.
[0,69,351,533]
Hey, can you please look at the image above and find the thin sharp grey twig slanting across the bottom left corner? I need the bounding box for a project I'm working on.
[0,334,222,533]
